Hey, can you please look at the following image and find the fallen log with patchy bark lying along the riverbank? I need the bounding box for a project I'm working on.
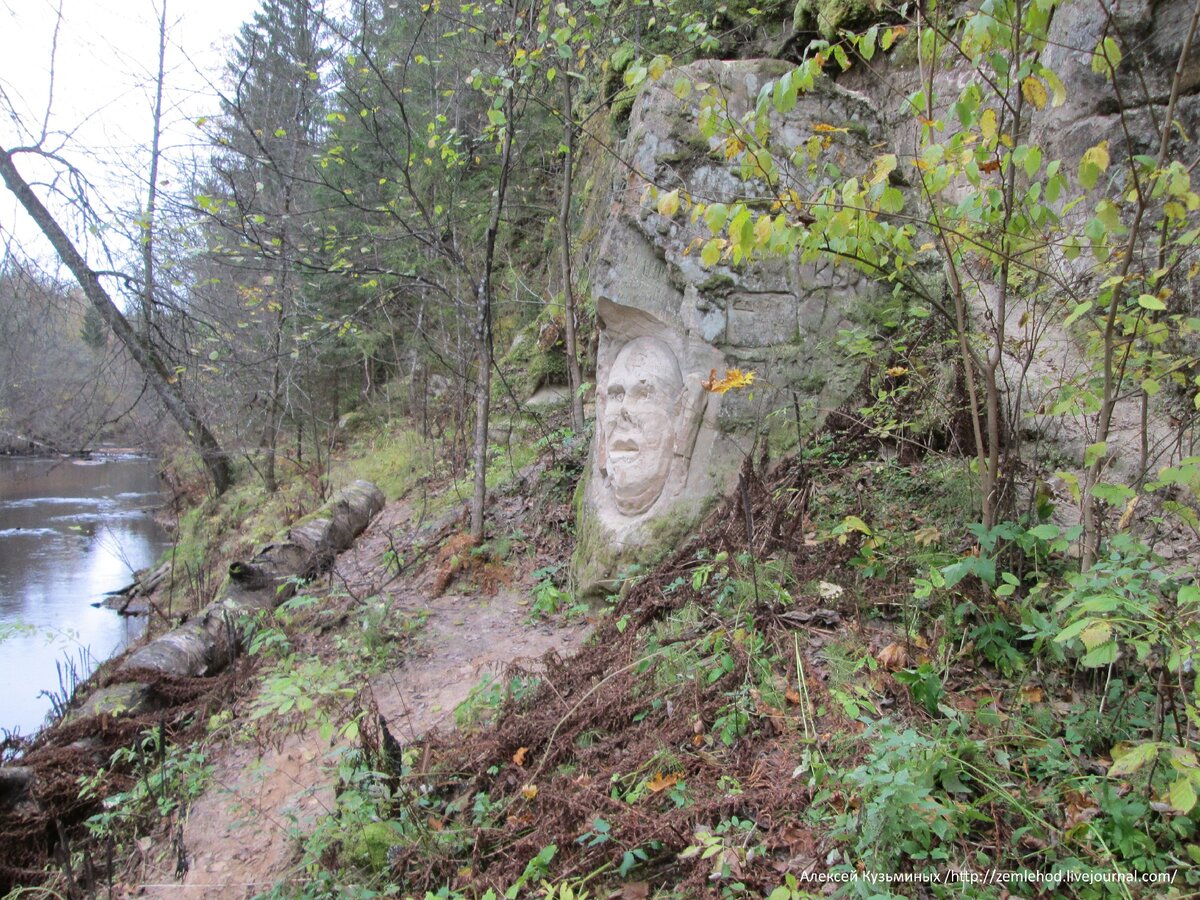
[68,481,384,721]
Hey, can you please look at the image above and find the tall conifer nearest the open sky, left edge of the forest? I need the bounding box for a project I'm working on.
[205,0,331,491]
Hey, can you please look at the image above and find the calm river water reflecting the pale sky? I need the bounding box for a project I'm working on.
[0,457,167,734]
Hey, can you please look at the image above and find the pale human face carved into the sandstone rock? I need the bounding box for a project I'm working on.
[602,337,684,516]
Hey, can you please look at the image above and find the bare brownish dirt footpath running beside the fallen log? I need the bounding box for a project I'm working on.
[138,503,586,898]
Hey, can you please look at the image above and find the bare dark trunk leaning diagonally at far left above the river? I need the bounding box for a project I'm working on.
[0,149,232,494]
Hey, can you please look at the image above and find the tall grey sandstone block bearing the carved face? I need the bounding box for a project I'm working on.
[575,60,890,595]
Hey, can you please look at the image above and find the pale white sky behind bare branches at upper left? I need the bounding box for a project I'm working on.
[0,0,258,266]
